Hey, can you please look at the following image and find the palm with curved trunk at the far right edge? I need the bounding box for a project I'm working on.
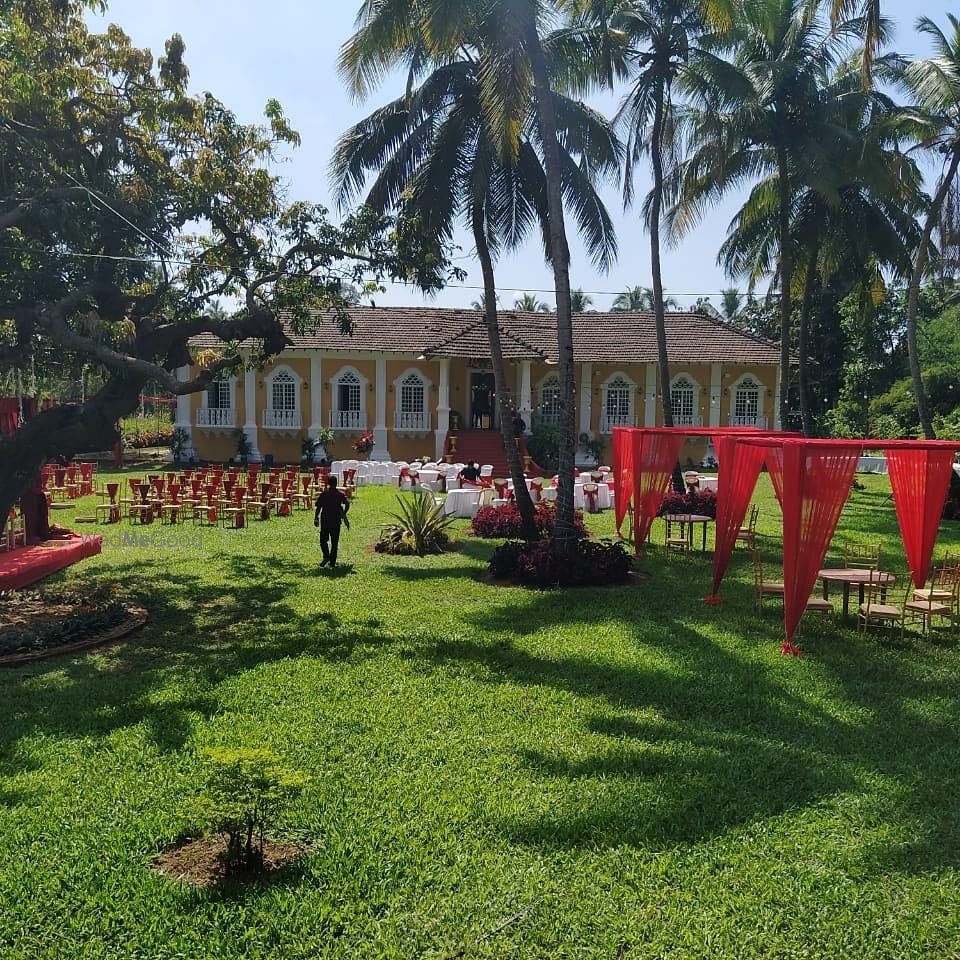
[905,14,960,439]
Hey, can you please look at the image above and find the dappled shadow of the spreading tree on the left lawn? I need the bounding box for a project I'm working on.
[0,557,392,774]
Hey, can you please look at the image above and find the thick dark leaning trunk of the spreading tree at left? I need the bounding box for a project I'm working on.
[0,376,145,533]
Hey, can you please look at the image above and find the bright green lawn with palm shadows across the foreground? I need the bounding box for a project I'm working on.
[0,477,960,960]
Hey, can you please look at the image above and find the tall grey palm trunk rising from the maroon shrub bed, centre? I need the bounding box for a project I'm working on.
[526,14,577,554]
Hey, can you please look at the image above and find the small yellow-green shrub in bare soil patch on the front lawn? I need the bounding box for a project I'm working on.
[187,747,307,874]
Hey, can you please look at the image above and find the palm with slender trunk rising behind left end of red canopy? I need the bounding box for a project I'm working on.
[615,0,704,427]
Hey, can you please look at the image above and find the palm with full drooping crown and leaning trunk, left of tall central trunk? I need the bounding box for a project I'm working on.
[333,13,620,535]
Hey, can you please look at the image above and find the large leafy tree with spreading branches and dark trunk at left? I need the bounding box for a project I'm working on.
[0,0,448,530]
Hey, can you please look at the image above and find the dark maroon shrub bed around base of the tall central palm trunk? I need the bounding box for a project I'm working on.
[489,540,633,587]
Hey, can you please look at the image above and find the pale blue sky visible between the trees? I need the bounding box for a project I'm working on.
[91,0,953,309]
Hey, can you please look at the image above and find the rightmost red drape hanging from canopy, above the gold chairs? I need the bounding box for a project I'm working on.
[886,444,956,587]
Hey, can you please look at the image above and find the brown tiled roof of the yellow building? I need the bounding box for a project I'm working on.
[191,307,780,363]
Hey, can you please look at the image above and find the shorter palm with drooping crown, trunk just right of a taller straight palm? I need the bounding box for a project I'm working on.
[719,63,921,436]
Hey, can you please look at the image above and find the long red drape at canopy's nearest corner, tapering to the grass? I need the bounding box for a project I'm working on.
[780,440,863,653]
